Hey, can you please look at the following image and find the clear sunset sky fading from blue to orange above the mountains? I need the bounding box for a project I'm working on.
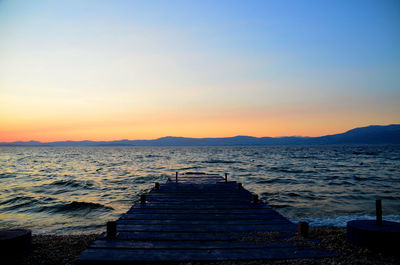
[0,0,400,142]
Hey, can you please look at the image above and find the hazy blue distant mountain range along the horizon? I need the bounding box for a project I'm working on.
[0,124,400,146]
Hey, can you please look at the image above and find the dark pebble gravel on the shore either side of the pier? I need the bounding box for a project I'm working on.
[6,227,400,265]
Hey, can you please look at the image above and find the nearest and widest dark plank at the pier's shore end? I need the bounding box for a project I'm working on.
[78,247,332,264]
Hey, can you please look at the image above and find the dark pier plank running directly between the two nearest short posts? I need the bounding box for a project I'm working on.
[117,223,297,233]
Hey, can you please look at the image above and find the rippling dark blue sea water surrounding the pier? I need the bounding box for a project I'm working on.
[0,146,400,234]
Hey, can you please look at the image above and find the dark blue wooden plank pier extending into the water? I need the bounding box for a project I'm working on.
[77,173,333,264]
